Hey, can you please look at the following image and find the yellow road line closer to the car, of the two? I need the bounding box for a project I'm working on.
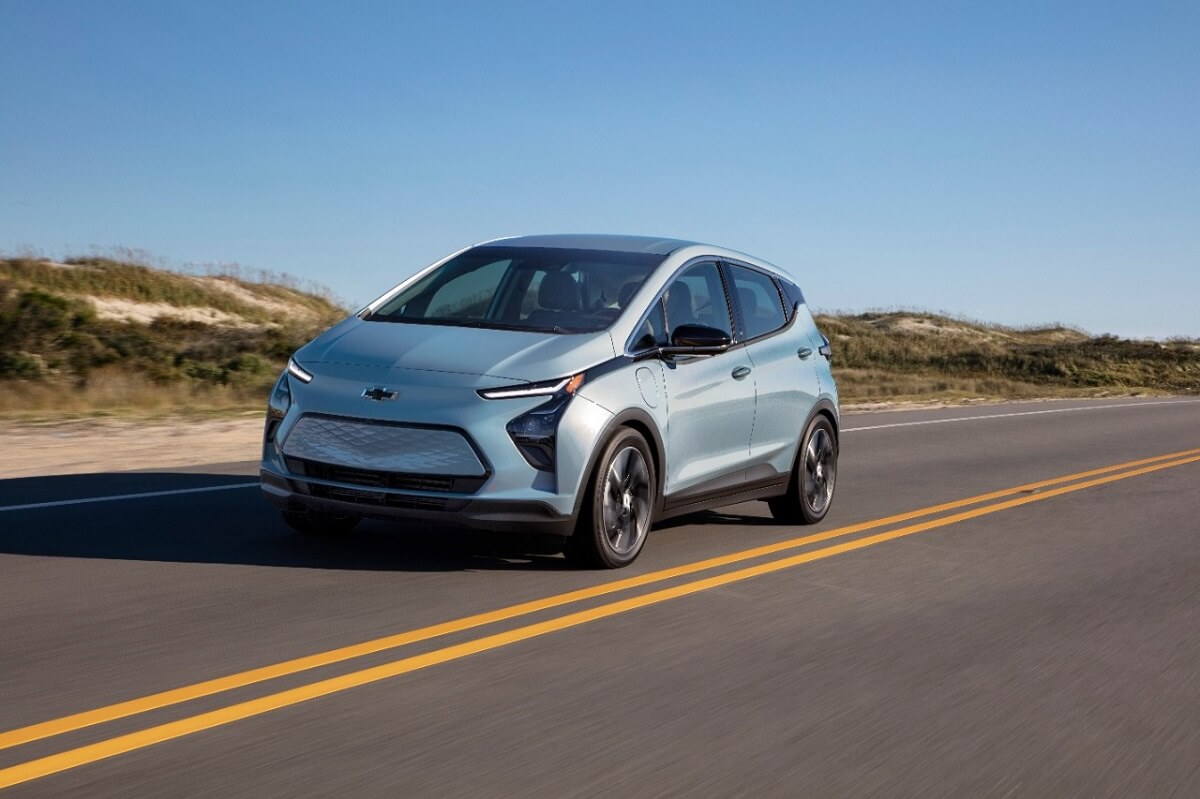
[0,449,1200,750]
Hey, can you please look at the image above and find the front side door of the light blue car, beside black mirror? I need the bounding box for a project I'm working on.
[662,260,755,501]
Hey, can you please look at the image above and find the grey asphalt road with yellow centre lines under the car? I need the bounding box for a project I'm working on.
[0,400,1200,798]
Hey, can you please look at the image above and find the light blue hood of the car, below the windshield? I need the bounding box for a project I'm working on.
[295,318,616,383]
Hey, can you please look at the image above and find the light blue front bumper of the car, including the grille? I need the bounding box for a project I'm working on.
[255,371,612,534]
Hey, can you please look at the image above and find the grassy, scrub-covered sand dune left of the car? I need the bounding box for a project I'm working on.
[0,258,346,413]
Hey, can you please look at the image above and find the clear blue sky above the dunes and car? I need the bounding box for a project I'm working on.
[0,0,1200,337]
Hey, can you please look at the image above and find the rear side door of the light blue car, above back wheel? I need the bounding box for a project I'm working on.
[725,263,820,482]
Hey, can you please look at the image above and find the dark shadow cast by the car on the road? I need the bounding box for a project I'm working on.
[0,471,769,572]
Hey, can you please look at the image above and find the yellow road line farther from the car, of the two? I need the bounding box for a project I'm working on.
[0,456,1200,788]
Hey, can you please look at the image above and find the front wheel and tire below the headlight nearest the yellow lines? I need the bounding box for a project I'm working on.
[565,427,659,569]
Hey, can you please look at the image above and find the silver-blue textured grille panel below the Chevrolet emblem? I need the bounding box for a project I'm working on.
[282,414,487,477]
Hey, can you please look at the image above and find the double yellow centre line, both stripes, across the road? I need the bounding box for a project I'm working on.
[0,449,1200,788]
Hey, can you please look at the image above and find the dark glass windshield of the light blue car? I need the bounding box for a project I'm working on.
[366,247,665,334]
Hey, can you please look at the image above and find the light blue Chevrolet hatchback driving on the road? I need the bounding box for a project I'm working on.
[262,235,839,567]
